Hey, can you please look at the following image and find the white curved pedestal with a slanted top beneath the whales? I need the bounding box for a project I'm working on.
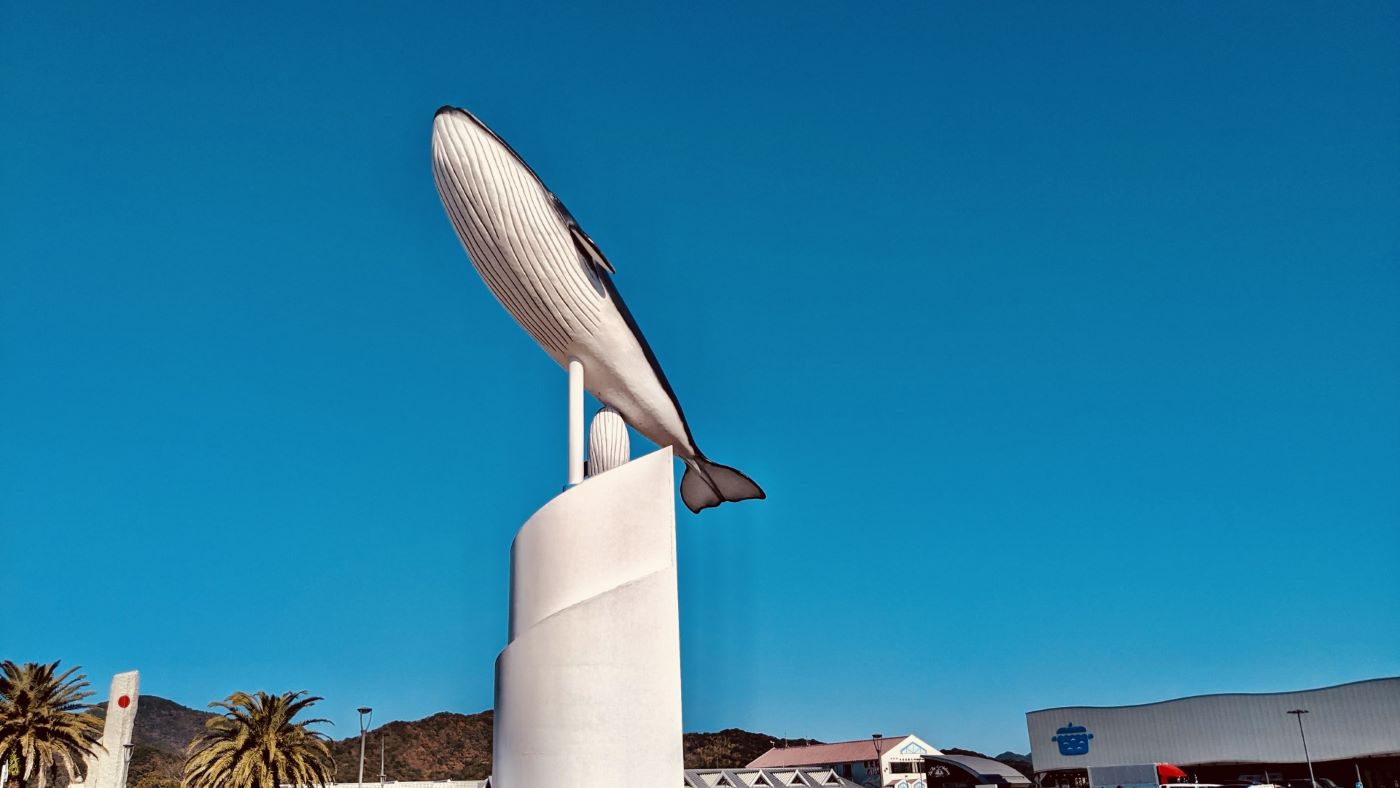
[491,448,685,788]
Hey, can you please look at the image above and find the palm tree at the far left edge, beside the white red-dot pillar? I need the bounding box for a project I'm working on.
[0,659,102,788]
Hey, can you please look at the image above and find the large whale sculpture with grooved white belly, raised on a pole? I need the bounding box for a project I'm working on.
[433,106,766,512]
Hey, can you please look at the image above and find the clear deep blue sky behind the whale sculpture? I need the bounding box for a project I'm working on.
[0,1,1400,752]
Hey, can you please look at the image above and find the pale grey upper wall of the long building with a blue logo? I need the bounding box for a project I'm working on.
[1026,677,1400,771]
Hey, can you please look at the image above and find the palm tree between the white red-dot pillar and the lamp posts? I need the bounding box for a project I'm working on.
[181,690,333,788]
